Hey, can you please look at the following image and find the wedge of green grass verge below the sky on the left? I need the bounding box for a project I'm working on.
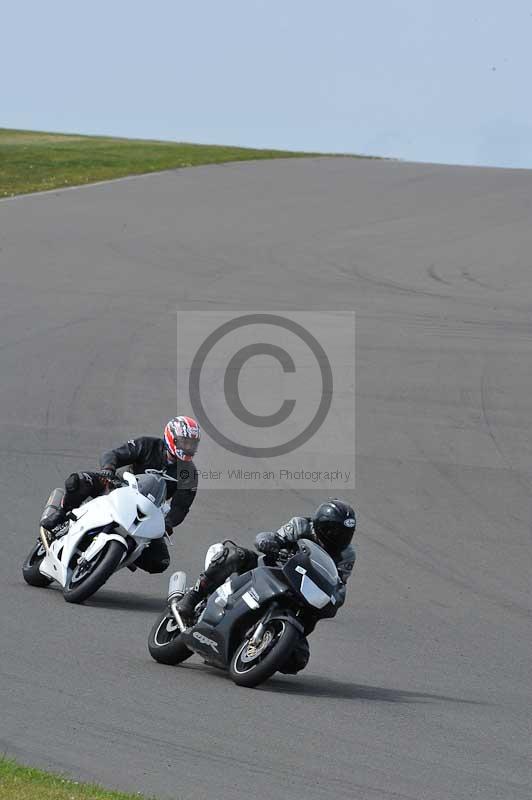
[0,128,318,198]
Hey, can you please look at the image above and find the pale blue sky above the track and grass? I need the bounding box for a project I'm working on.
[0,0,532,167]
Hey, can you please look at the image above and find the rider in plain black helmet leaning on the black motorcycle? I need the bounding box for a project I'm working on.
[177,498,356,674]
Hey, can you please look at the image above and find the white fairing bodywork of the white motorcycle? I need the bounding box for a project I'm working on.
[40,472,165,586]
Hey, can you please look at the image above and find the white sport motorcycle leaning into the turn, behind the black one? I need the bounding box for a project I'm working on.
[22,470,177,603]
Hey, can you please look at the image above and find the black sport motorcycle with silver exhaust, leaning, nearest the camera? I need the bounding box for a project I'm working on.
[148,539,342,687]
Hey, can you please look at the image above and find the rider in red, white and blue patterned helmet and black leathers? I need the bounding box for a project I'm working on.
[41,416,200,573]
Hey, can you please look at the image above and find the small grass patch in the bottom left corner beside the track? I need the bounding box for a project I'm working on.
[0,757,155,800]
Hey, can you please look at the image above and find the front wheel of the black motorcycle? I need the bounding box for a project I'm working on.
[229,619,300,688]
